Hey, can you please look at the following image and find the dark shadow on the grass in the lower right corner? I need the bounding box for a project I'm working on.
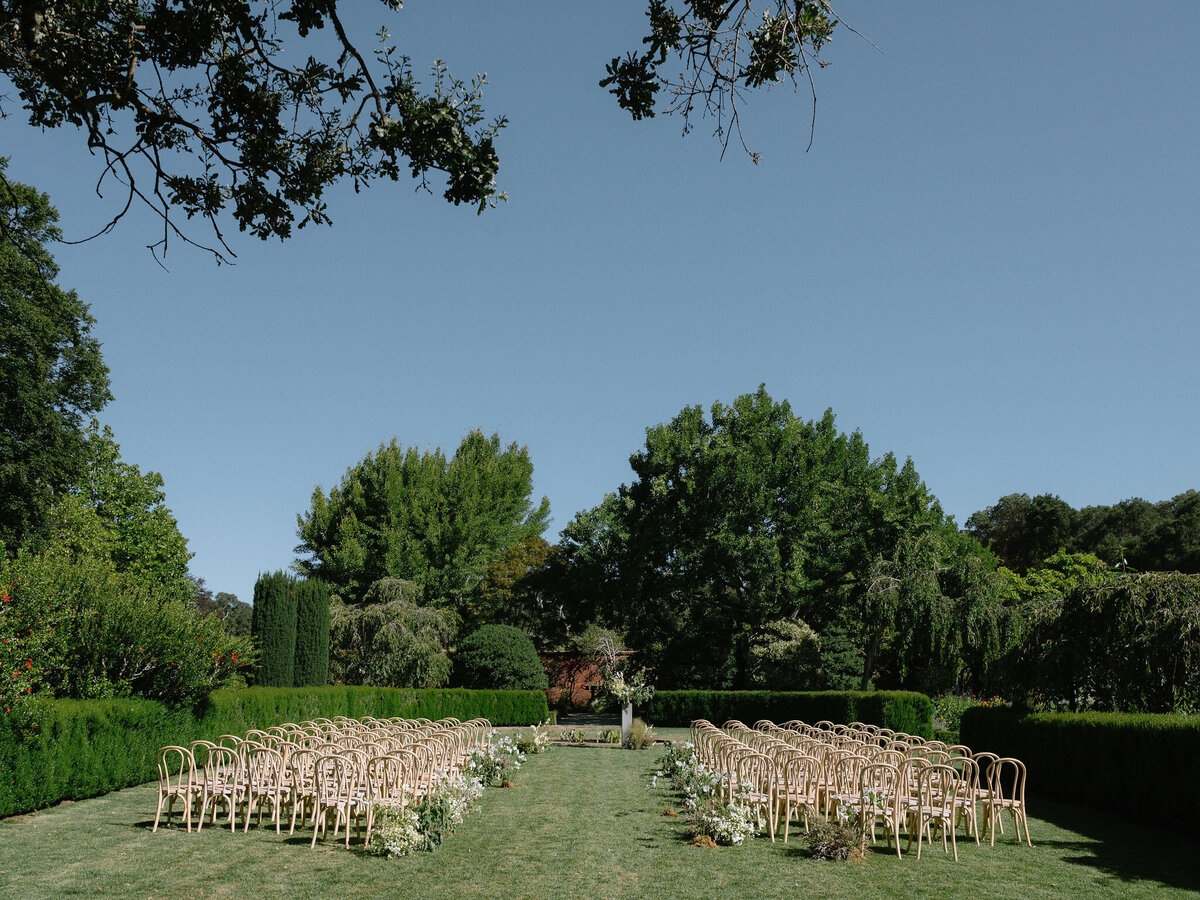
[1033,800,1200,892]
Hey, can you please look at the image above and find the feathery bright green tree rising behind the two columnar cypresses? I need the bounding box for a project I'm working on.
[296,431,550,612]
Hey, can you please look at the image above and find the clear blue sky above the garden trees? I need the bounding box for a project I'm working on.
[0,0,1200,600]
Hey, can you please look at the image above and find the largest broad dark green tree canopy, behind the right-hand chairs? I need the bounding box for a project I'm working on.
[560,388,995,686]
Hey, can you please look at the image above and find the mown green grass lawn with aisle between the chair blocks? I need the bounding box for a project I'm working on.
[0,746,1200,900]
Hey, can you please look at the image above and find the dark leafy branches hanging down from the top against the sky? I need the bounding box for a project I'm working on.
[0,0,836,260]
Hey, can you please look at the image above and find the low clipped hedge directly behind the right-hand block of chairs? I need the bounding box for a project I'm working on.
[635,691,934,738]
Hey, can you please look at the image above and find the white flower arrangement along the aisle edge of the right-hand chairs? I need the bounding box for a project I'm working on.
[650,742,758,846]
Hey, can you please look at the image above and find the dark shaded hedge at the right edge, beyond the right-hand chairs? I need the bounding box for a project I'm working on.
[961,707,1200,833]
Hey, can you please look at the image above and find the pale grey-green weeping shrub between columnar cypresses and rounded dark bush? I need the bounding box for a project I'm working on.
[330,578,458,688]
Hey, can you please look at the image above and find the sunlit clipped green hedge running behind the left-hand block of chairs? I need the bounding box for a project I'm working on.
[0,686,550,816]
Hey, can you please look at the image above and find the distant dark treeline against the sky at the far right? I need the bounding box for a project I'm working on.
[966,491,1200,574]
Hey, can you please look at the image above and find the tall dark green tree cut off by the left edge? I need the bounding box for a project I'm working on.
[0,158,112,550]
